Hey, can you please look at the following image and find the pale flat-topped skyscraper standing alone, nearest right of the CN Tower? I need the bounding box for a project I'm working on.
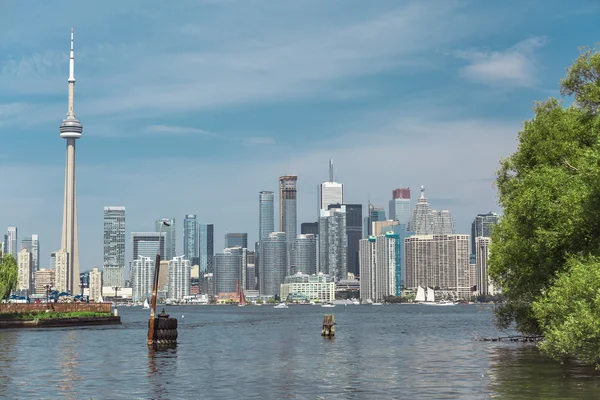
[102,206,125,287]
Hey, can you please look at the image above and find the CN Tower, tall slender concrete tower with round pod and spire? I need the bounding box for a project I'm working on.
[60,29,83,294]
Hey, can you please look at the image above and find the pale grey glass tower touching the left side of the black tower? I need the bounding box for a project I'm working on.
[319,205,348,281]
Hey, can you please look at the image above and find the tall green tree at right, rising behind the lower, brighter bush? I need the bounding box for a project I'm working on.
[489,46,600,362]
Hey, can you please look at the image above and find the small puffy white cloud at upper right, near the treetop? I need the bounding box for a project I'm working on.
[456,37,546,87]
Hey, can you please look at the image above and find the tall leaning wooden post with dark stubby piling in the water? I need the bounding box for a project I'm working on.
[148,221,177,348]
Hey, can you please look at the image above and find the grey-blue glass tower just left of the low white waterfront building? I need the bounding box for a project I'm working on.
[259,232,288,296]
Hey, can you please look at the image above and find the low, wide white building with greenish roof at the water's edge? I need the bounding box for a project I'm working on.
[280,272,335,303]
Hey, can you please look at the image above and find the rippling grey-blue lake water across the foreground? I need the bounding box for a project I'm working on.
[0,305,600,399]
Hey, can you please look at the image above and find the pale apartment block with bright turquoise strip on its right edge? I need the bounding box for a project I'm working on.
[360,232,402,302]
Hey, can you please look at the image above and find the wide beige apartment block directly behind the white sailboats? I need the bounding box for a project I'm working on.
[404,234,471,298]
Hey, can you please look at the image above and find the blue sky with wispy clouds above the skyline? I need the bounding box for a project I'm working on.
[0,0,600,270]
